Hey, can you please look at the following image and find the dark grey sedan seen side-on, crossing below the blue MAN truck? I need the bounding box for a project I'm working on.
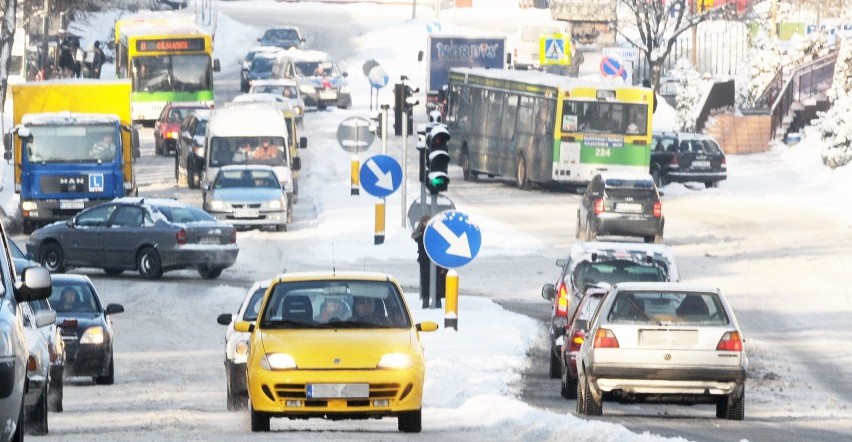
[27,197,239,279]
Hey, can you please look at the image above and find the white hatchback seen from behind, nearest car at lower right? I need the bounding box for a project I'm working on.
[577,282,748,420]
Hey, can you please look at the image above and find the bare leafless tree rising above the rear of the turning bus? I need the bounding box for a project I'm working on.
[616,0,736,91]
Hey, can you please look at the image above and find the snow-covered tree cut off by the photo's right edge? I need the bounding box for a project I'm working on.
[818,39,852,169]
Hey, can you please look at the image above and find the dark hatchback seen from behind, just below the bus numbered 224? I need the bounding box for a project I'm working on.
[576,172,666,244]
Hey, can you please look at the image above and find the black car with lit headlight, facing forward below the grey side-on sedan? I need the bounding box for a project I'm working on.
[50,274,124,385]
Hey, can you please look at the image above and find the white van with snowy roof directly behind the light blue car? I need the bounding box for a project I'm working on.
[201,106,302,208]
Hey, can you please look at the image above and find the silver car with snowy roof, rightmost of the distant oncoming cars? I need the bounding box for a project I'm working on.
[272,49,352,109]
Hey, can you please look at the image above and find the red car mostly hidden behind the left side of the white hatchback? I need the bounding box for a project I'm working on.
[559,287,607,399]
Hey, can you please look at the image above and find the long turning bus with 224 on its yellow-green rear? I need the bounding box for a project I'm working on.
[445,68,654,189]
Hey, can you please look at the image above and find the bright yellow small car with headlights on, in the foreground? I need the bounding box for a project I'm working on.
[234,272,438,433]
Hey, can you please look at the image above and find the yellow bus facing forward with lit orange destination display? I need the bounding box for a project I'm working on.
[115,13,219,124]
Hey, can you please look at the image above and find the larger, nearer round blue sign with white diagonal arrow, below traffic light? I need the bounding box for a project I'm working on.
[423,210,482,268]
